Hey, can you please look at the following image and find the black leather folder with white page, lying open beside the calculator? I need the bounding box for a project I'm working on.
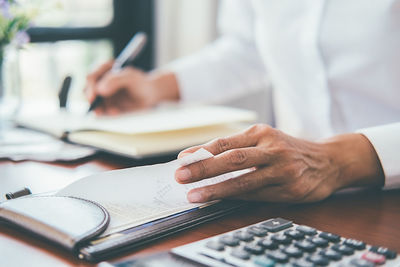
[0,149,251,261]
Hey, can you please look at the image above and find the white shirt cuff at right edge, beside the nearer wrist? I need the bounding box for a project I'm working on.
[357,122,400,189]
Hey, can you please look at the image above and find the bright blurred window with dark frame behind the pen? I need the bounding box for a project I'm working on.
[20,0,153,109]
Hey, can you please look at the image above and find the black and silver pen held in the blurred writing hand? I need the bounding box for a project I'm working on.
[88,32,147,113]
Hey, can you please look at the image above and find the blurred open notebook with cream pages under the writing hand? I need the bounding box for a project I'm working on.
[17,106,256,158]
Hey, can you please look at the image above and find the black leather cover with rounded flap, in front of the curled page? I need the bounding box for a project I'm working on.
[0,195,246,262]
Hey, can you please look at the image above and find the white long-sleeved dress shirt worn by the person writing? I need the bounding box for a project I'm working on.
[170,0,400,187]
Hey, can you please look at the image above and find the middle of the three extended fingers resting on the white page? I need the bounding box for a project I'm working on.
[175,147,272,183]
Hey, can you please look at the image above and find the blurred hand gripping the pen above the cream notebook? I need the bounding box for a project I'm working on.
[85,61,179,115]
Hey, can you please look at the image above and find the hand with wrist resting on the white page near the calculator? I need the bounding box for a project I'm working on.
[175,124,384,202]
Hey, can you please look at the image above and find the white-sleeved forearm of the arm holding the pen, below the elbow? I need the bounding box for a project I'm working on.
[166,36,268,103]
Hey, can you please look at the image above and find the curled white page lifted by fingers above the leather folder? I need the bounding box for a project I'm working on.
[56,149,244,236]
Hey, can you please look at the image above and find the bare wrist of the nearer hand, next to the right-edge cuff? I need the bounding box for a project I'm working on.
[322,134,384,190]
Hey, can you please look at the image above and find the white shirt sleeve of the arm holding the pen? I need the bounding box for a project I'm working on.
[166,0,267,103]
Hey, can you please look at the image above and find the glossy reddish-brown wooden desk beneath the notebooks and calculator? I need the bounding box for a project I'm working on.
[0,155,400,266]
